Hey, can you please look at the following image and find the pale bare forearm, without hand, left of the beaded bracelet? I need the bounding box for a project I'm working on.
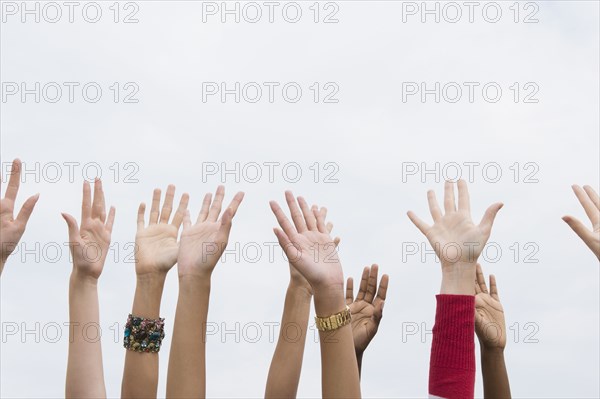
[65,272,106,398]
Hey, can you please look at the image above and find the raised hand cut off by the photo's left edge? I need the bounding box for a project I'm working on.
[0,159,40,273]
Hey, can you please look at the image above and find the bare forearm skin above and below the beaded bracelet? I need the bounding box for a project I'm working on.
[121,275,166,398]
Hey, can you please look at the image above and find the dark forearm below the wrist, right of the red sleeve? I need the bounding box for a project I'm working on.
[481,346,511,399]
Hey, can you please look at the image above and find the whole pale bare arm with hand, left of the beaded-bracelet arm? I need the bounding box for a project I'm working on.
[62,180,115,398]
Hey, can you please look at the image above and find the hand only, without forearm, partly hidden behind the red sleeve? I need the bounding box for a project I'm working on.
[475,264,506,349]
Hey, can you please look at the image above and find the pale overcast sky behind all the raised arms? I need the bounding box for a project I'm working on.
[0,1,600,398]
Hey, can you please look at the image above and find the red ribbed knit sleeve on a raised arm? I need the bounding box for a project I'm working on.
[429,295,475,399]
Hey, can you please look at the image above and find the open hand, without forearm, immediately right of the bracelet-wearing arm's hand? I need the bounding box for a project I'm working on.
[177,186,244,277]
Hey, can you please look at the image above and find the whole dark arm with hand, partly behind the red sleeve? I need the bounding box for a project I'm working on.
[475,264,511,399]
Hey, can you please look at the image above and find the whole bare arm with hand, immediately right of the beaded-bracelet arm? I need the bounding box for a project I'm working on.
[167,186,244,398]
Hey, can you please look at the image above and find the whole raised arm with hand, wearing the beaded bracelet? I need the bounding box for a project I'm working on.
[121,185,189,398]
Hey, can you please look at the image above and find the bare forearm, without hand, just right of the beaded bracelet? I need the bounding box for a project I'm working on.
[167,276,210,398]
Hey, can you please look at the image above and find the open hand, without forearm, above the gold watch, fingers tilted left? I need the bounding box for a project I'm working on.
[270,191,344,290]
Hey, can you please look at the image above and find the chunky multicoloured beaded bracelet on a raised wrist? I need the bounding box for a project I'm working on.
[123,314,165,353]
